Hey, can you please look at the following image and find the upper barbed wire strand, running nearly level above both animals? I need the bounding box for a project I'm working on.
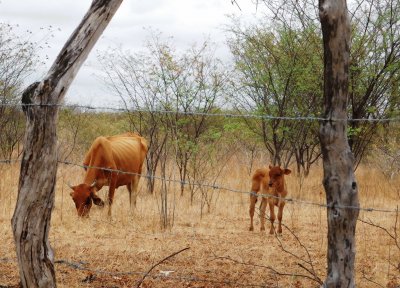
[0,102,400,122]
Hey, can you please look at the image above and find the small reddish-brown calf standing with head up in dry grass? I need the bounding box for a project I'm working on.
[249,166,291,234]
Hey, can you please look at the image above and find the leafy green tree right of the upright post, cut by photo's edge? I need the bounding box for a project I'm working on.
[348,0,400,165]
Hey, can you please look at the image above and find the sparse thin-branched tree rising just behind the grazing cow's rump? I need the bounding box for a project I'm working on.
[98,36,168,193]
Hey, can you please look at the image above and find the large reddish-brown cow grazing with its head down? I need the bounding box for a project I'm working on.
[70,132,147,216]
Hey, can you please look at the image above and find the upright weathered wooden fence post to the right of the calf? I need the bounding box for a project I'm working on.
[319,0,359,288]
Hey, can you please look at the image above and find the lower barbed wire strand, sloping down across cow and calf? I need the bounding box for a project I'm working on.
[0,159,398,213]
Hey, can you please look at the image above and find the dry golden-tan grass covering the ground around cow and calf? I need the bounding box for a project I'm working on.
[0,160,400,288]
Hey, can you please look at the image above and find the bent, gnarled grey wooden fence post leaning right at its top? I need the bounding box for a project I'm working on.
[11,0,122,288]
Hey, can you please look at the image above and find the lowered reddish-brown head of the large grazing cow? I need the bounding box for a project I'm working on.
[70,182,104,217]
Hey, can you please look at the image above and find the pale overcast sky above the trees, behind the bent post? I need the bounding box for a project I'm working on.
[0,0,263,106]
